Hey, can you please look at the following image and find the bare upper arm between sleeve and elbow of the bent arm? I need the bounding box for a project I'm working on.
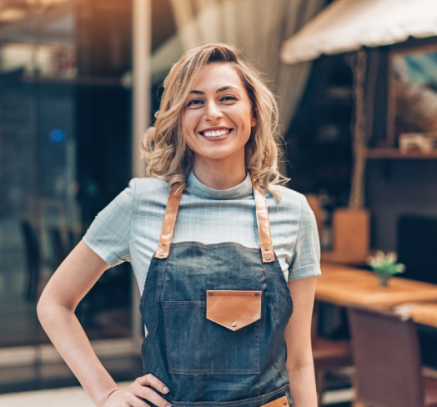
[38,241,110,312]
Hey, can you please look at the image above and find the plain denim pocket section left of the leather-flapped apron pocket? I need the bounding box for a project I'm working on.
[164,301,207,374]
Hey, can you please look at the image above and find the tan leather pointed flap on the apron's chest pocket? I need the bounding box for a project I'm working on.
[206,290,262,331]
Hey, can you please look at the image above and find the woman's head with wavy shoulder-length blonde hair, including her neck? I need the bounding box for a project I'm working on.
[141,44,285,202]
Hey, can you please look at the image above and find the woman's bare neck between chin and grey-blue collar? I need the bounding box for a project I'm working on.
[193,157,246,190]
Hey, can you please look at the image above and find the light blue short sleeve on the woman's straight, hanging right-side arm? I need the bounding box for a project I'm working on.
[288,195,321,281]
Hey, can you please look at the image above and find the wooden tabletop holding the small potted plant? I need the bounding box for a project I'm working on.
[316,263,437,308]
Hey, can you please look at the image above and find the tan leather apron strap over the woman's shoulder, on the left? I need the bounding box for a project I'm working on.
[155,184,183,259]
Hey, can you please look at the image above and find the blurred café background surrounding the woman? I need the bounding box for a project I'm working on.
[0,0,437,407]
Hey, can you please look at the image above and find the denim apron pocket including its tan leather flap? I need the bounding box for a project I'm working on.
[206,290,262,374]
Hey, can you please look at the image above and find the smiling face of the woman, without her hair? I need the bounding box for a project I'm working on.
[182,63,256,163]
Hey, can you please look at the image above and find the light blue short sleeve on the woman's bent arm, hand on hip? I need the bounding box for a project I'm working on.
[83,180,135,266]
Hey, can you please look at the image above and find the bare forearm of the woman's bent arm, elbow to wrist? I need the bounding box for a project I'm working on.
[38,302,118,407]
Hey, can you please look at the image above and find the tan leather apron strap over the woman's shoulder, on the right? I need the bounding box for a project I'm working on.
[252,181,275,263]
